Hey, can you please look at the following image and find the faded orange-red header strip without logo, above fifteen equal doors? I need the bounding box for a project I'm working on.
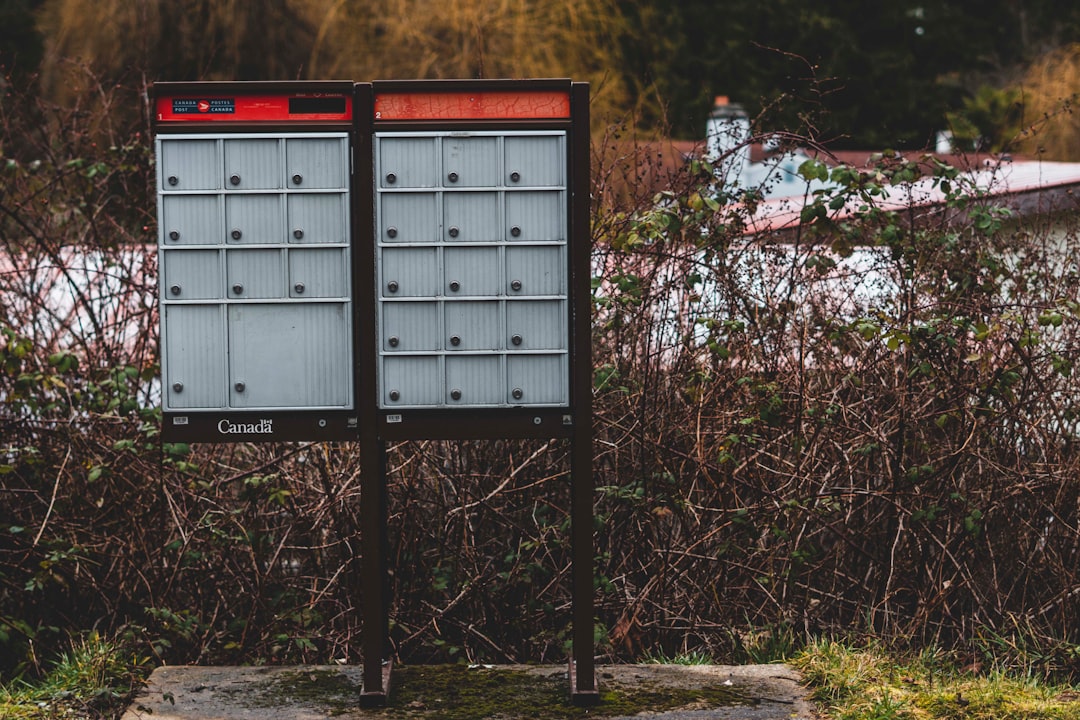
[375,91,570,121]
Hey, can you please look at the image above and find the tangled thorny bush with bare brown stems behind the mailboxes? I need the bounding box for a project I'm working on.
[0,80,1080,686]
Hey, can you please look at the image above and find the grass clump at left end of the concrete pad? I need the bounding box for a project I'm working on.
[0,634,144,720]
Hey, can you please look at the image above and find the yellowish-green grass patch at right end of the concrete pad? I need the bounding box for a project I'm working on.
[789,640,1080,720]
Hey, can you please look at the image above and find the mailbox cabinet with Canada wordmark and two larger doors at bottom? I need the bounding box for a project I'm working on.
[154,82,359,441]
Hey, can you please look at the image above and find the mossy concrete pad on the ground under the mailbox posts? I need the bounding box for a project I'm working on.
[122,665,819,720]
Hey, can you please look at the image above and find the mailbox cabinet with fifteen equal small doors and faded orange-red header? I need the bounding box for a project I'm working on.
[372,80,591,439]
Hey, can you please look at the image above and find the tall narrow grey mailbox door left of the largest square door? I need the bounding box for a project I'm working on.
[162,304,225,410]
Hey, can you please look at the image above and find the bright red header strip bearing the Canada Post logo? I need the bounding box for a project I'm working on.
[156,93,352,123]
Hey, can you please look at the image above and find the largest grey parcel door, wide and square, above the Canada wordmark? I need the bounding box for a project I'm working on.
[229,302,352,408]
